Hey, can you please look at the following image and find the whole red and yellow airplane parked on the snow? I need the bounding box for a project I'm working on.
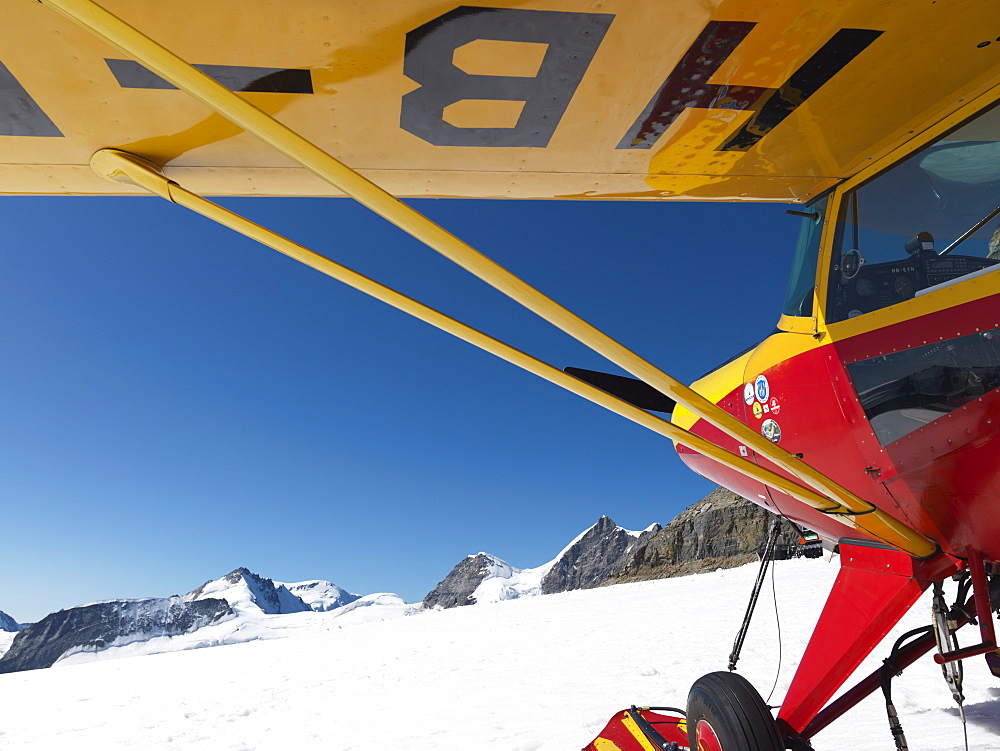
[7,0,1000,751]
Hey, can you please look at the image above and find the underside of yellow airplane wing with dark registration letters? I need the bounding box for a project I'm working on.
[0,0,1000,201]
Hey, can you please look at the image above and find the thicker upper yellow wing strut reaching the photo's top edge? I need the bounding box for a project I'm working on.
[42,0,936,557]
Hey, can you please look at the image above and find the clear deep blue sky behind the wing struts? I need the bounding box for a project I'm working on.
[0,197,798,621]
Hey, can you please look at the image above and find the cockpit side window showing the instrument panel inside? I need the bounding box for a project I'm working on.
[827,102,1000,322]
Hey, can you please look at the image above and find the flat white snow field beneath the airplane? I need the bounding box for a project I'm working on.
[0,560,1000,751]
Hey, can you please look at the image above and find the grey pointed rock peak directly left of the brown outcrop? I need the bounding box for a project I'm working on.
[542,516,660,594]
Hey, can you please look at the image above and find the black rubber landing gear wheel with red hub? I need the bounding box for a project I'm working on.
[687,672,785,751]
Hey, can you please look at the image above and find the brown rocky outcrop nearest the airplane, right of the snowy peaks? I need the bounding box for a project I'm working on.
[608,488,798,584]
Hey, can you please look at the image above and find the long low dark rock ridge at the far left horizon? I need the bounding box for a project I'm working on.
[0,597,233,673]
